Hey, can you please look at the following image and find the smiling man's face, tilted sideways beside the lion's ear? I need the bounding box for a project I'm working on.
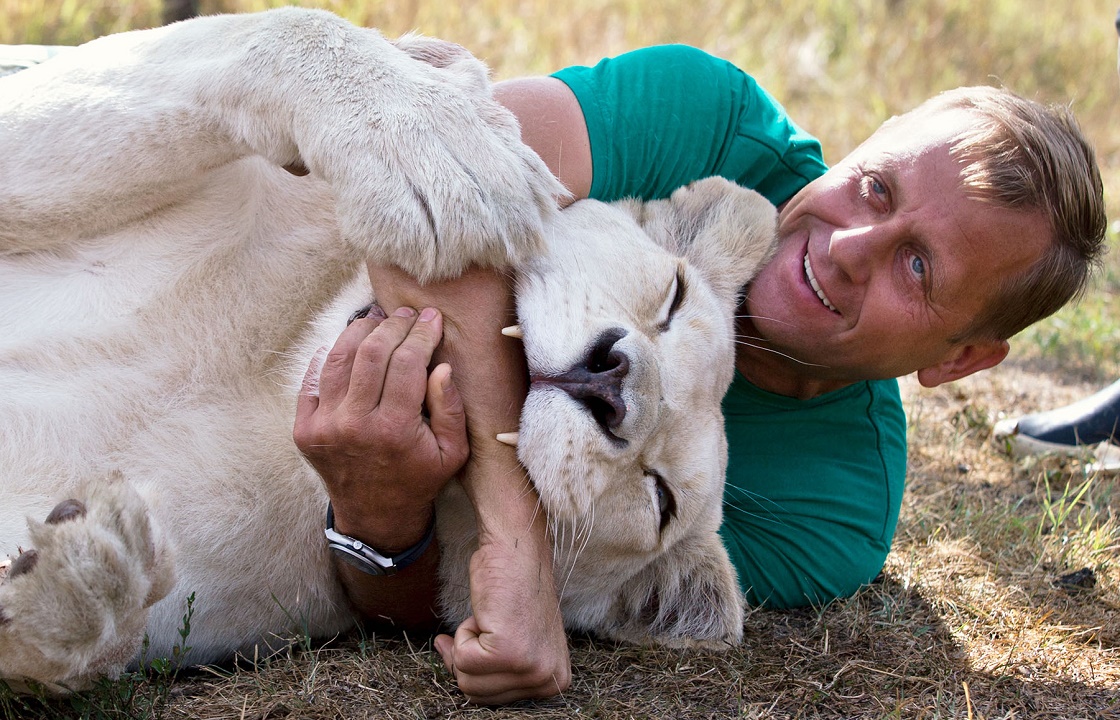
[740,110,1049,386]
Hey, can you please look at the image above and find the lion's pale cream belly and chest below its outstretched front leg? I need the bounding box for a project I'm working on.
[0,161,358,662]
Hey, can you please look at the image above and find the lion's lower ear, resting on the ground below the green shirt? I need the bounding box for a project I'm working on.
[608,532,744,649]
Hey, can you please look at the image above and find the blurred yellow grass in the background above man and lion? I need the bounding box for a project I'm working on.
[0,0,1120,166]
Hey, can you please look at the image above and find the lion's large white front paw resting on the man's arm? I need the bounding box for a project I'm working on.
[312,38,566,282]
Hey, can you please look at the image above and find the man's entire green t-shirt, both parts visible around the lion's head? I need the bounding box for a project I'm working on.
[554,45,906,607]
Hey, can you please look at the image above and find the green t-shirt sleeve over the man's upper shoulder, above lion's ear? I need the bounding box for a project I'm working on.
[554,45,827,205]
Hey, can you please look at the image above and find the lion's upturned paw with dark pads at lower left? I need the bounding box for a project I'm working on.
[0,477,174,690]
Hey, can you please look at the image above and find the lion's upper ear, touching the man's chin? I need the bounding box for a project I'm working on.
[632,178,777,298]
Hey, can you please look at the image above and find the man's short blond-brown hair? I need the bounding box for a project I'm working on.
[911,86,1107,342]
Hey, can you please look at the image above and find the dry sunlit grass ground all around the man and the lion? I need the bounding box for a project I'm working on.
[0,0,1120,719]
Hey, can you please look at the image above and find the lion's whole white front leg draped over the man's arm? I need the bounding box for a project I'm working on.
[0,8,563,280]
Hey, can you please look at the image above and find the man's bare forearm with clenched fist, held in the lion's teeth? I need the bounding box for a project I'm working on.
[389,270,571,704]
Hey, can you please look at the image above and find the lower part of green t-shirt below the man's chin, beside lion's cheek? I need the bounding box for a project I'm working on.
[720,374,906,607]
